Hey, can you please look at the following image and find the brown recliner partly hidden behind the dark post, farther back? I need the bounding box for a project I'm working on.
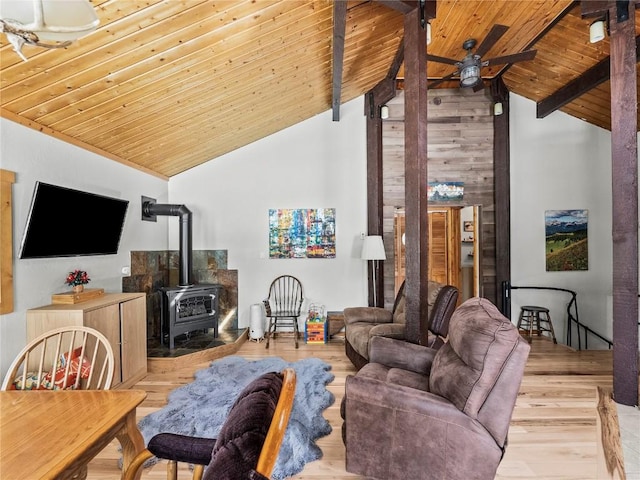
[343,281,458,368]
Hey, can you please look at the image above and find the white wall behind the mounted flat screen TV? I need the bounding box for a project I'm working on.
[0,118,168,378]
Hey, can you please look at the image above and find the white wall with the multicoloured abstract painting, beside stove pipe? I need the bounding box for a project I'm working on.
[169,98,367,327]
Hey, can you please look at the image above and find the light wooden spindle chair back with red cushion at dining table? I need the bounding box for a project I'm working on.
[1,326,115,390]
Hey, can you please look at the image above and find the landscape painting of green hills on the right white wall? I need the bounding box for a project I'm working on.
[544,210,589,272]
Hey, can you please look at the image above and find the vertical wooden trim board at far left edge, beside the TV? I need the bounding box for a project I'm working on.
[0,169,16,314]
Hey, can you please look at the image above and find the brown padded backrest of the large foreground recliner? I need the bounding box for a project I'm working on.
[429,298,520,419]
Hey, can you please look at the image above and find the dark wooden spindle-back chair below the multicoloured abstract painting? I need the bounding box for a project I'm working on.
[263,275,304,348]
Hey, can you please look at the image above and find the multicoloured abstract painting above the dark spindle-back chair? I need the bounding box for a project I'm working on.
[269,208,336,258]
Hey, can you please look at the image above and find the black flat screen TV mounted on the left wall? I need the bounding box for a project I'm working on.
[20,182,129,258]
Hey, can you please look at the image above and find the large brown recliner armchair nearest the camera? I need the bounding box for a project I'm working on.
[341,298,529,480]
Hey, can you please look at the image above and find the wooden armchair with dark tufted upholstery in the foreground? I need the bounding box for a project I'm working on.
[124,368,296,480]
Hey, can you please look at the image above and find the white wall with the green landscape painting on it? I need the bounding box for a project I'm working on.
[510,94,612,348]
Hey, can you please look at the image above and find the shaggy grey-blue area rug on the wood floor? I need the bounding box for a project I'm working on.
[138,355,335,480]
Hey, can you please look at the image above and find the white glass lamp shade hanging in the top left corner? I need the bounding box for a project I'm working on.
[0,0,100,42]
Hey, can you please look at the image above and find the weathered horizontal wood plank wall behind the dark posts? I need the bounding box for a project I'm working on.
[382,89,499,307]
